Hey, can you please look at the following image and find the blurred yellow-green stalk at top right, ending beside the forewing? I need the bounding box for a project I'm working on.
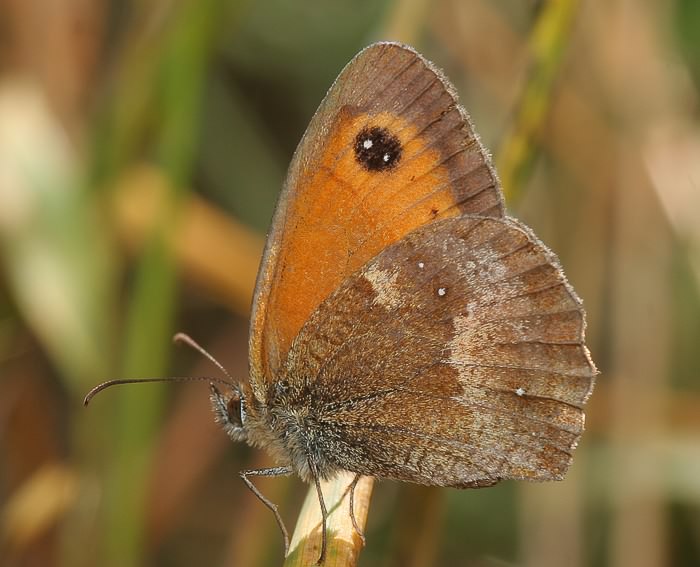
[496,0,578,202]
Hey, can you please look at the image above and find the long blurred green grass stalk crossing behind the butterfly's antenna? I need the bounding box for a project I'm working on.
[91,0,230,566]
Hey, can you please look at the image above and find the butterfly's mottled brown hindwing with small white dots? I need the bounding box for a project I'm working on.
[282,216,595,486]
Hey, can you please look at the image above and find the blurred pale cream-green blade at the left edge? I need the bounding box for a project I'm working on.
[0,84,113,393]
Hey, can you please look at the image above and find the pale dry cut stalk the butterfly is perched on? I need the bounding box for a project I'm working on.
[284,472,374,567]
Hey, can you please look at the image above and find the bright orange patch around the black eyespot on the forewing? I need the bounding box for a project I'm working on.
[263,109,459,372]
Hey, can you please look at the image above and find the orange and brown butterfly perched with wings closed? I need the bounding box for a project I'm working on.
[83,42,596,562]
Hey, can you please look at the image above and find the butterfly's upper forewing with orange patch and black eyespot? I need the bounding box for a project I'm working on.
[250,43,503,399]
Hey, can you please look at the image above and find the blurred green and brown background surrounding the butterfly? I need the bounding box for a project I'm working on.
[0,0,700,567]
